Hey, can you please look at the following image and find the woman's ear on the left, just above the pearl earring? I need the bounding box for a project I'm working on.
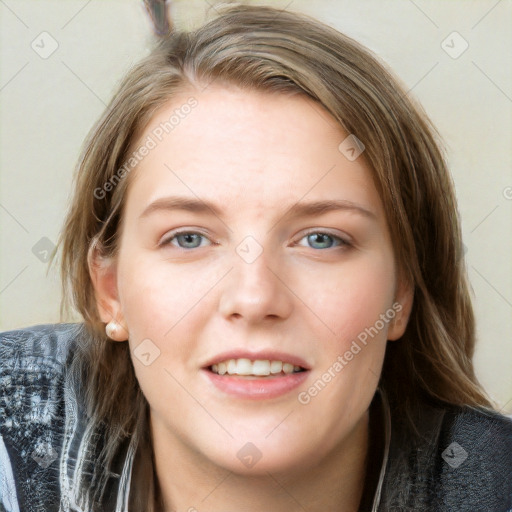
[88,247,128,341]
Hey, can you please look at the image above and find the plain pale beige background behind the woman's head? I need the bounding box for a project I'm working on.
[0,0,512,413]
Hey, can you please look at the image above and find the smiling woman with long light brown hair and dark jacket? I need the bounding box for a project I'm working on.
[0,6,512,512]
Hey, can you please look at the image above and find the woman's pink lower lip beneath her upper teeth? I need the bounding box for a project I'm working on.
[203,370,309,400]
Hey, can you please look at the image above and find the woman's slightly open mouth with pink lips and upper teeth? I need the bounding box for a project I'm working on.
[203,353,310,400]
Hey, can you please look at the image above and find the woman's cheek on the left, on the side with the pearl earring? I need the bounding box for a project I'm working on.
[118,251,226,403]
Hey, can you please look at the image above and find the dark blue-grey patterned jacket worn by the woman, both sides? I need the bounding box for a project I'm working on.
[0,324,512,512]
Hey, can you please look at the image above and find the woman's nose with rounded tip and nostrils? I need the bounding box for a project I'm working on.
[219,251,293,324]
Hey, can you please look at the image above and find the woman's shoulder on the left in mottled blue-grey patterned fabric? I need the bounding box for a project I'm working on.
[0,324,85,511]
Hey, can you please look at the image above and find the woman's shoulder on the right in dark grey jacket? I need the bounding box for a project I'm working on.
[383,403,512,512]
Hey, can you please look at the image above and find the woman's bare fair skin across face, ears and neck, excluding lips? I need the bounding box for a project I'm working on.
[93,85,412,512]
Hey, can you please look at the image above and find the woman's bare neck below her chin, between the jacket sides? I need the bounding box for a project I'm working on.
[151,413,368,512]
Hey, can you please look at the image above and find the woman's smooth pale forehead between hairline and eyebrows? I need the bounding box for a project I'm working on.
[121,85,381,218]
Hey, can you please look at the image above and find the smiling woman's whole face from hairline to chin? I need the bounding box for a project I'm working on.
[94,85,410,474]
